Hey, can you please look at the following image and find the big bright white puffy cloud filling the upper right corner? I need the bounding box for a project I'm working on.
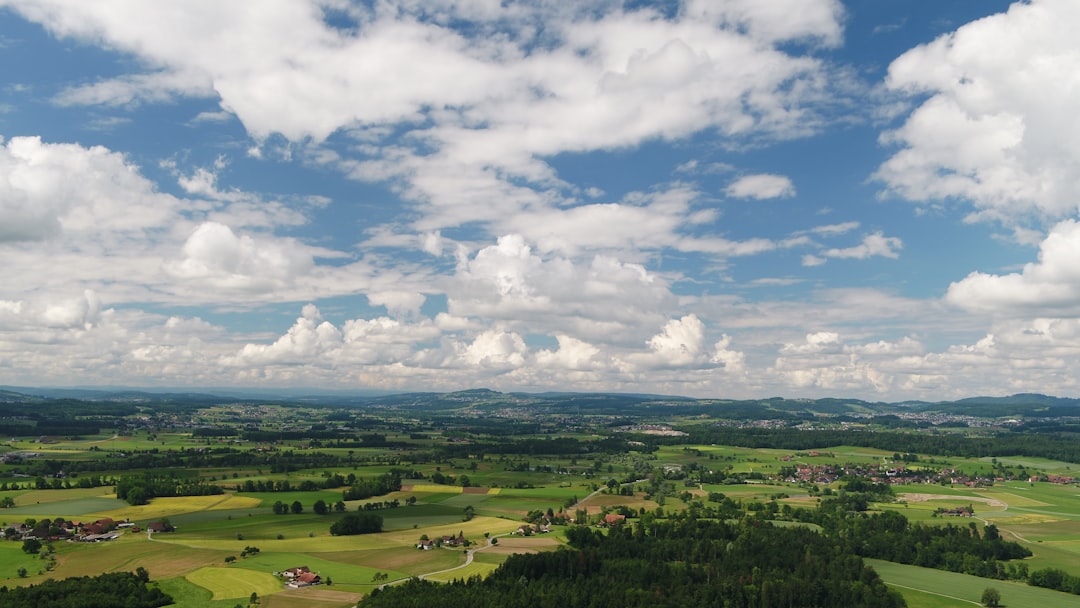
[876,0,1080,224]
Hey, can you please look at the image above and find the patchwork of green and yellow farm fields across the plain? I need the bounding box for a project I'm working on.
[0,393,1080,608]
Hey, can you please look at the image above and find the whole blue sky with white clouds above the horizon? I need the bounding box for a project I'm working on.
[0,0,1080,402]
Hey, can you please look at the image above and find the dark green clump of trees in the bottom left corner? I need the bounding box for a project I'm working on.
[0,568,173,608]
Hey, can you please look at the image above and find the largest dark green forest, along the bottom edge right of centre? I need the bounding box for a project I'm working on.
[364,518,905,608]
